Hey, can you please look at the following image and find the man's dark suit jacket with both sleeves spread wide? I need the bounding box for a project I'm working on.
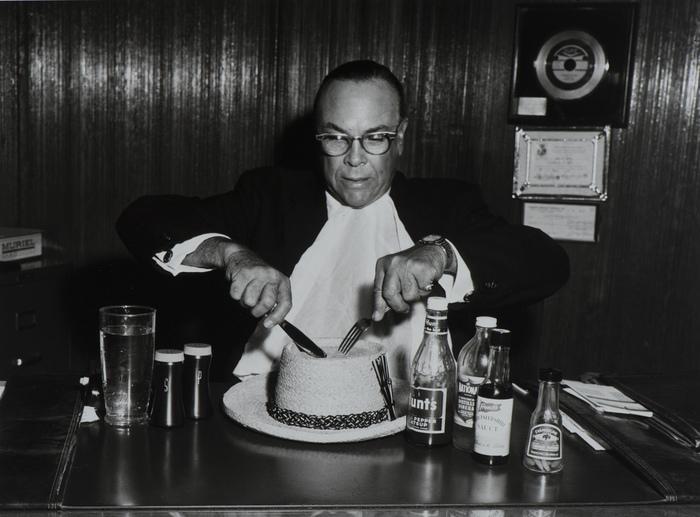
[117,168,569,310]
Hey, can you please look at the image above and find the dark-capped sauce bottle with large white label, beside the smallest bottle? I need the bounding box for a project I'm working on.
[474,329,513,465]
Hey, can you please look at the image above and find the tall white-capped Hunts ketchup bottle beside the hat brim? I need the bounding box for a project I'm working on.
[406,296,455,447]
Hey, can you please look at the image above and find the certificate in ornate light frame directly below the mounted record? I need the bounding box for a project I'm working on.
[513,127,610,202]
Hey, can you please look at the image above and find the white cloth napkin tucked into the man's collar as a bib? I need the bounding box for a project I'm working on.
[233,192,425,379]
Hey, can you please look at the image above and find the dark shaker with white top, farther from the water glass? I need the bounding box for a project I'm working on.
[184,343,211,420]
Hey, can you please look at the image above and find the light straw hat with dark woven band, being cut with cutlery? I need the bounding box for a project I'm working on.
[222,338,409,443]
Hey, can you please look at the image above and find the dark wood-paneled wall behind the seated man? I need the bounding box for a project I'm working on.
[0,0,700,375]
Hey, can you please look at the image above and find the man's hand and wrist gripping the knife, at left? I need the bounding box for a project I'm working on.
[183,237,292,328]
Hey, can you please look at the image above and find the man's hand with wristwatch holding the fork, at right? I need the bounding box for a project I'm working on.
[372,242,447,321]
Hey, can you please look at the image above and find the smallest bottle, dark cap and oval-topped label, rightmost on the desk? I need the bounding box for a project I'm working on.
[523,368,564,474]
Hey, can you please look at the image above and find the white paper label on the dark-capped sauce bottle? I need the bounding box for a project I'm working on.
[474,396,513,456]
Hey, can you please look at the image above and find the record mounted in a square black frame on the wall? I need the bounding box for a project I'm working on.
[509,3,637,127]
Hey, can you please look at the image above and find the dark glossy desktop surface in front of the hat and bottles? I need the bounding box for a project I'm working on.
[58,380,663,510]
